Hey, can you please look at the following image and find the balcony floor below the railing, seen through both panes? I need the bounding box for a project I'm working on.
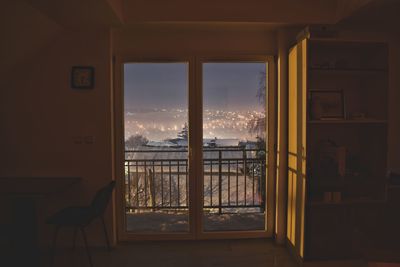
[126,211,265,232]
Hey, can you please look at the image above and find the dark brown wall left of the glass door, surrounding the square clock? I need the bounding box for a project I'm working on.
[0,29,113,247]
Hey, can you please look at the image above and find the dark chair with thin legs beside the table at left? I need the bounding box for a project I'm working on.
[47,181,115,267]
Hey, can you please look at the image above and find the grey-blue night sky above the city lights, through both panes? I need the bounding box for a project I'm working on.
[124,63,265,110]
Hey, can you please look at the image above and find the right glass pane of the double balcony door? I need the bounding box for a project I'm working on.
[201,61,268,233]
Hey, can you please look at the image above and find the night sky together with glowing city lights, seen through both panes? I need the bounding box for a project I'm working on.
[124,62,266,140]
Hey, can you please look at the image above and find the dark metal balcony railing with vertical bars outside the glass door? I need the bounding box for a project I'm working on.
[125,147,266,213]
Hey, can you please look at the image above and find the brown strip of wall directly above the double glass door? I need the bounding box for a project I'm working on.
[114,23,277,59]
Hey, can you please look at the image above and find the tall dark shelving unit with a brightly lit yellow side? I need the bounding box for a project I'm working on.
[287,39,388,260]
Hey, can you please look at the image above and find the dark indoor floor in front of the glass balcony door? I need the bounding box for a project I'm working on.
[44,239,297,267]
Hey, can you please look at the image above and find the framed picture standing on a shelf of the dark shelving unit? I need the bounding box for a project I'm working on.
[310,90,345,120]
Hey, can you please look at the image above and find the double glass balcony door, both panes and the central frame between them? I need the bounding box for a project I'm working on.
[119,57,274,239]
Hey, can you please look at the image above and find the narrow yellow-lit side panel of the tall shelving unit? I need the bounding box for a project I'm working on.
[287,39,307,258]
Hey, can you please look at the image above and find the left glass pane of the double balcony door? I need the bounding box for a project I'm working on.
[123,62,190,234]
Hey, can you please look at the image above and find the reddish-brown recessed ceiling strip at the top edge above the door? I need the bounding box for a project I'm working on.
[124,0,337,24]
